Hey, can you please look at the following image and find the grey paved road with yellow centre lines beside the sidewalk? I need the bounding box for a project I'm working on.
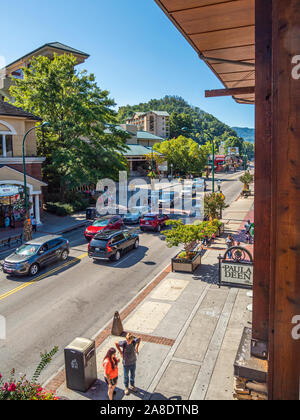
[0,170,245,381]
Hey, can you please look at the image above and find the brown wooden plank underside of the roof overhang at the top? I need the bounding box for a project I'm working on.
[155,0,255,104]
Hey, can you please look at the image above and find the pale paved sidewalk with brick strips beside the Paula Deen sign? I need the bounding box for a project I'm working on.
[45,193,253,400]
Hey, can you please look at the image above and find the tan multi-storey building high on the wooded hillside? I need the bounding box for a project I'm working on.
[126,111,170,139]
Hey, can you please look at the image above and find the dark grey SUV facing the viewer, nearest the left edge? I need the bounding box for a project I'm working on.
[2,235,70,276]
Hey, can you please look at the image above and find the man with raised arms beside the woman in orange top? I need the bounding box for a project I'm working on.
[116,333,141,395]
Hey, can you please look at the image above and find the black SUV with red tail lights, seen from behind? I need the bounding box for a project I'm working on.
[88,230,139,261]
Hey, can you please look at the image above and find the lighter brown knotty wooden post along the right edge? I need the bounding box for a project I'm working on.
[266,0,300,400]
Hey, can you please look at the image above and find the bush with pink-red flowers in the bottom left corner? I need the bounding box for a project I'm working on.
[0,347,59,401]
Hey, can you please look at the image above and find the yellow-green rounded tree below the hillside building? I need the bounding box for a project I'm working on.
[154,136,207,175]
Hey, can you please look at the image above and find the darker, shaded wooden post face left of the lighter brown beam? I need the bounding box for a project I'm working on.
[252,0,272,354]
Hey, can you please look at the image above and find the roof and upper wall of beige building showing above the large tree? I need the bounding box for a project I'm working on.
[0,42,89,100]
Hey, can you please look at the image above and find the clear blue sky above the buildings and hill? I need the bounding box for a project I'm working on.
[0,0,254,128]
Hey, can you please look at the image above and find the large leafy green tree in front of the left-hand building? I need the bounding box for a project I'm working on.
[10,54,127,199]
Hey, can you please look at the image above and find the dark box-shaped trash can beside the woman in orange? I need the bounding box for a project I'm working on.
[65,338,97,392]
